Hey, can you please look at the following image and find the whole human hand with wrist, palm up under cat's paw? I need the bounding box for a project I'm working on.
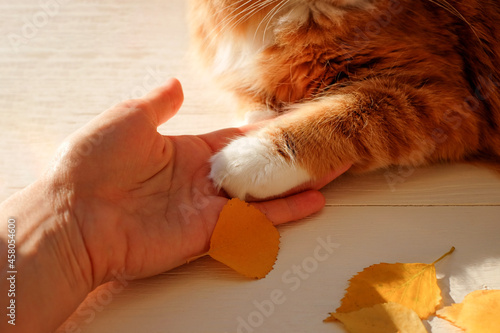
[0,80,352,332]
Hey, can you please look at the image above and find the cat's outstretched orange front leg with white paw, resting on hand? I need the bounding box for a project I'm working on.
[211,80,478,199]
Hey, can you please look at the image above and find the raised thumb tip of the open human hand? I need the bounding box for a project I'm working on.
[143,78,184,126]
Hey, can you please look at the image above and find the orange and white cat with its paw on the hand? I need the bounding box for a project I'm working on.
[190,0,500,199]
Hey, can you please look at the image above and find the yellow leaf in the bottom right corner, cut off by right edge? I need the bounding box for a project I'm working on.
[437,290,500,333]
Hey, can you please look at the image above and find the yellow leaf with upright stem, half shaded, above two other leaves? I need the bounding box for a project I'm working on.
[337,248,455,319]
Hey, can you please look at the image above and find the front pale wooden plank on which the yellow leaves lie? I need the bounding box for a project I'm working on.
[63,207,500,333]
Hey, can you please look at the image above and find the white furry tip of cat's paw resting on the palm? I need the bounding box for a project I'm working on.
[210,135,311,200]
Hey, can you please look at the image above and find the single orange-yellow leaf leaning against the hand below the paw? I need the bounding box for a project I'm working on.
[208,199,280,279]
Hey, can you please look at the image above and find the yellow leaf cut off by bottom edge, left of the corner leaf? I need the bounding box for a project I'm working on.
[326,303,428,333]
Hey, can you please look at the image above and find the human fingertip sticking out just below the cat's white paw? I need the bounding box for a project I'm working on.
[252,190,325,225]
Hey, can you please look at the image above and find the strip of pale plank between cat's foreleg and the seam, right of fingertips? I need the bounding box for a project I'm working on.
[324,164,500,206]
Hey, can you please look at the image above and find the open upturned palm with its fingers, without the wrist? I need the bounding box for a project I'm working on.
[54,80,344,287]
